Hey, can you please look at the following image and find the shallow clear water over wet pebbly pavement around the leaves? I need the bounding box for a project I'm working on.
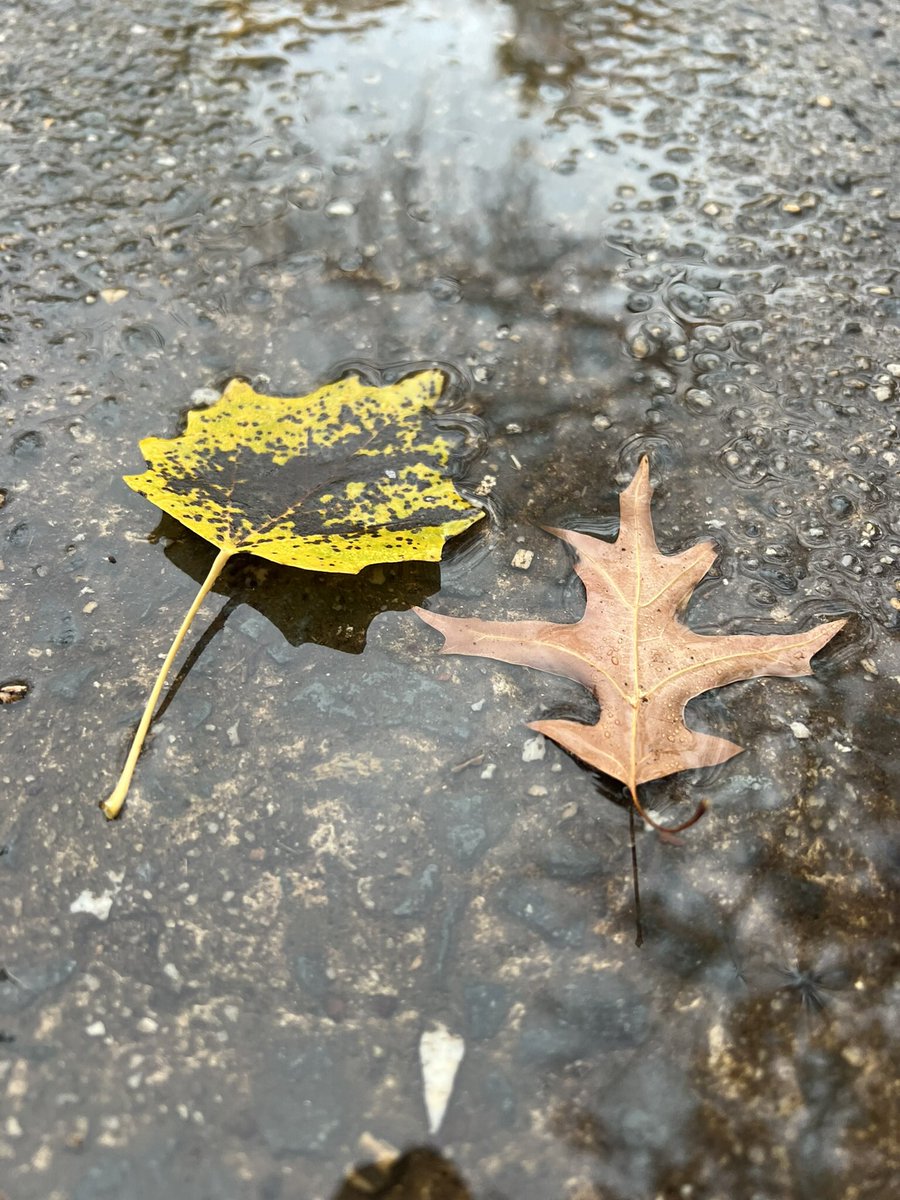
[0,0,900,1200]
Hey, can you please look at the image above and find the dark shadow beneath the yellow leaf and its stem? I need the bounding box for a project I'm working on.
[150,515,440,720]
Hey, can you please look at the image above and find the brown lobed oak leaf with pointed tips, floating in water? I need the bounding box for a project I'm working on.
[415,458,845,832]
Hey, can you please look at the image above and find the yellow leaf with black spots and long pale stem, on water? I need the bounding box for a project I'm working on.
[101,371,482,818]
